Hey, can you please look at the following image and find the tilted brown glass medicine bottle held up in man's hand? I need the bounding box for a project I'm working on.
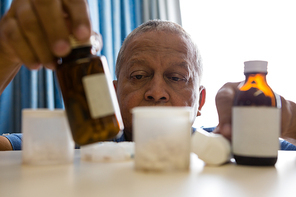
[56,37,123,145]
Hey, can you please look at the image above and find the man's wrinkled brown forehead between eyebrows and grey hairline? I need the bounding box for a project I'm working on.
[119,31,196,77]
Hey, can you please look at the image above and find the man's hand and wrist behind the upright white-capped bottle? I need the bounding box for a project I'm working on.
[214,83,296,145]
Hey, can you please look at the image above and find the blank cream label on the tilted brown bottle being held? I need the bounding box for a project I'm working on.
[82,73,114,119]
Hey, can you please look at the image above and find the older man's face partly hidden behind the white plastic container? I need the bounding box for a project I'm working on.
[115,31,199,140]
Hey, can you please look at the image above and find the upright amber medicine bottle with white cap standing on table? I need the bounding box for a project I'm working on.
[232,61,281,166]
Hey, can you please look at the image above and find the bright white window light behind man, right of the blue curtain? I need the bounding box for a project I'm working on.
[180,0,296,126]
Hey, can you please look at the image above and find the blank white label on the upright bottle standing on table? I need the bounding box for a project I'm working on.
[232,107,281,157]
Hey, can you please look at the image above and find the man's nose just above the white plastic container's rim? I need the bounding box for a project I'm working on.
[145,76,169,103]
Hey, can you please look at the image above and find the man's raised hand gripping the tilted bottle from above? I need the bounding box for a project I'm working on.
[0,0,91,70]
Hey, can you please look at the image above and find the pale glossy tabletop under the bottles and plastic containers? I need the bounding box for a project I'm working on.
[0,150,296,197]
